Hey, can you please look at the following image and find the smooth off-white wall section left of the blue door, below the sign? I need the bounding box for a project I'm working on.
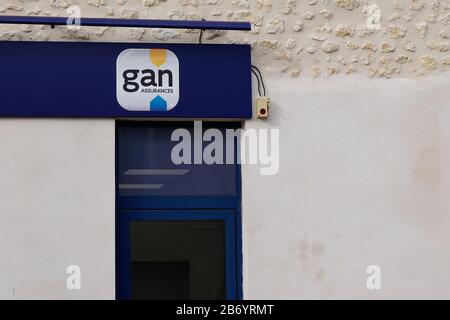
[0,119,115,299]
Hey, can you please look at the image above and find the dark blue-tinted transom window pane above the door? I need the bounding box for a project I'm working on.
[118,121,237,197]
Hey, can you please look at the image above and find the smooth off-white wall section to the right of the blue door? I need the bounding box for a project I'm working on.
[243,74,450,299]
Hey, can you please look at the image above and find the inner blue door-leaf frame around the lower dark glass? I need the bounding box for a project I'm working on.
[118,210,237,300]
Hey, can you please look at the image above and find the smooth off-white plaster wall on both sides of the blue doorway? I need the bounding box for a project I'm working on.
[0,75,450,299]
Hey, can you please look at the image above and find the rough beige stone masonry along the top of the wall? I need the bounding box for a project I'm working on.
[0,0,450,78]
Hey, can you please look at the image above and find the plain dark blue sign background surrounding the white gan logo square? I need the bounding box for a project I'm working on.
[0,42,252,119]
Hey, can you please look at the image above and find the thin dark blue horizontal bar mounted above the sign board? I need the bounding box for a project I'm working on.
[0,16,251,30]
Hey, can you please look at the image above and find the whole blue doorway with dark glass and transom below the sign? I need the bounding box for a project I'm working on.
[116,121,242,300]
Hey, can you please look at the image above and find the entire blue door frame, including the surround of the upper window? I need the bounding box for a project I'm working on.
[116,121,243,300]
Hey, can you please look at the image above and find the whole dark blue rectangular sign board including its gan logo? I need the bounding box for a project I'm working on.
[0,41,252,119]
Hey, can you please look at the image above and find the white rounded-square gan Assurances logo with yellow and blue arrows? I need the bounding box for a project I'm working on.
[116,49,180,111]
